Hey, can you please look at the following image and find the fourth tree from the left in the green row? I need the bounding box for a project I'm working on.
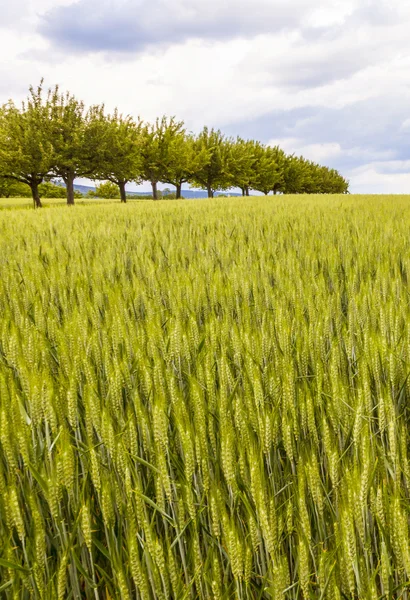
[141,117,185,200]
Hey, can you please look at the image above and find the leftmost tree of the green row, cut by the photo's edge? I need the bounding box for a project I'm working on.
[0,82,54,208]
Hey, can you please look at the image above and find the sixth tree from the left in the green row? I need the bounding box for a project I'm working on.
[190,127,232,198]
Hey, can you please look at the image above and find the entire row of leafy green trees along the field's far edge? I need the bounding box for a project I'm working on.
[0,83,348,207]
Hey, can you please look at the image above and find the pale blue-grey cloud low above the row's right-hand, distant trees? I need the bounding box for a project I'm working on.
[222,96,410,175]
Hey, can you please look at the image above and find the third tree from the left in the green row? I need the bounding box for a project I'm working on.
[94,110,142,202]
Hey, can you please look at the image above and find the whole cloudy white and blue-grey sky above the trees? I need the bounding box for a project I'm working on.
[0,0,410,193]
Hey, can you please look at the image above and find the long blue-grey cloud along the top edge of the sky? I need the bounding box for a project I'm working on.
[39,0,320,52]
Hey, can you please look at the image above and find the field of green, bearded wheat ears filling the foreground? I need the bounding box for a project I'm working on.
[0,196,410,600]
